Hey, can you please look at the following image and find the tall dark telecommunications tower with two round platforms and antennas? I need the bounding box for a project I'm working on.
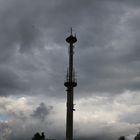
[64,29,77,140]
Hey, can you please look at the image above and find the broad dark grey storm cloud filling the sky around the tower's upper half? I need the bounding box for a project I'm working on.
[0,0,139,96]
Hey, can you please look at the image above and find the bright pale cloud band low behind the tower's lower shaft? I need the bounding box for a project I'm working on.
[0,91,140,140]
